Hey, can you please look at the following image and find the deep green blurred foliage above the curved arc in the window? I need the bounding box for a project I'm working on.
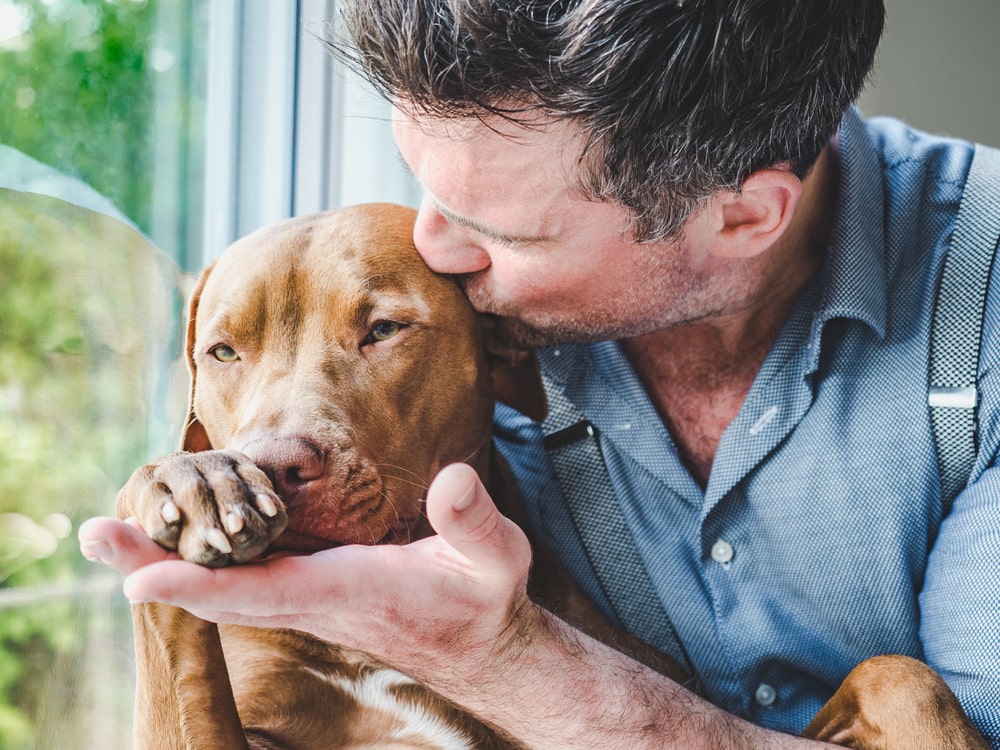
[0,0,157,227]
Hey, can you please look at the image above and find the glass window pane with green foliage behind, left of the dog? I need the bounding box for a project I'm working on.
[0,0,208,750]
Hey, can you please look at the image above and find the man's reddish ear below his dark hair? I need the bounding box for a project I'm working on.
[715,167,802,258]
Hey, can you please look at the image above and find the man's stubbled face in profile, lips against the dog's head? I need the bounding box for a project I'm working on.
[393,106,718,347]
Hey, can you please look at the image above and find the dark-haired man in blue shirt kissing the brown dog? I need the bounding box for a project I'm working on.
[82,0,1000,748]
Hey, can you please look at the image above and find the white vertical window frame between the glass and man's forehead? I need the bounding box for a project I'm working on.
[200,0,420,265]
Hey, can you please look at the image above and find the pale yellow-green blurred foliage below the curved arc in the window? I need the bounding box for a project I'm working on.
[0,190,184,750]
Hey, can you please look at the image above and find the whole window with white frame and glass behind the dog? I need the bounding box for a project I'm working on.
[0,0,416,750]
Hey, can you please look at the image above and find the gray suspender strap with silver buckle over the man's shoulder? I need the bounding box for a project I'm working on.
[927,146,1000,516]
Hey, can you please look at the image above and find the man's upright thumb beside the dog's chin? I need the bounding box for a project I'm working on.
[427,464,531,574]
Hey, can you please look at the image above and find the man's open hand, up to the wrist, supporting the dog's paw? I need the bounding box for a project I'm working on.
[79,464,531,683]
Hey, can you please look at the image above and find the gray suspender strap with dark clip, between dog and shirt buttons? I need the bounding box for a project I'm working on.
[542,378,693,675]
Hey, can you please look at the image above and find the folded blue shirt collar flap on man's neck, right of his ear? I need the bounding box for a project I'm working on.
[810,108,888,371]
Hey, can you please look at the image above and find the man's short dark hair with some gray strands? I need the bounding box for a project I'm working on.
[330,0,885,241]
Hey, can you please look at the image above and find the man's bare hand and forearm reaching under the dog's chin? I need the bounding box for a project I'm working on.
[79,464,813,750]
